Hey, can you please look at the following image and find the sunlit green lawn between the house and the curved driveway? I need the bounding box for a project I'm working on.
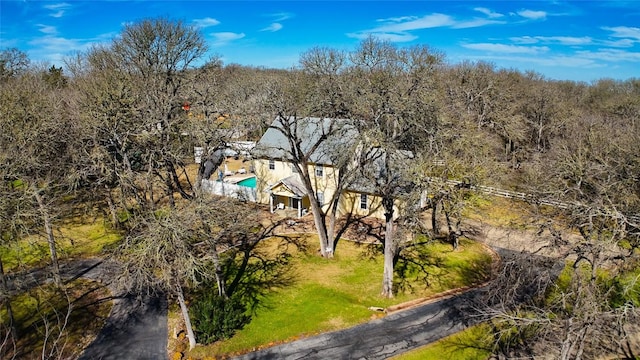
[189,237,491,358]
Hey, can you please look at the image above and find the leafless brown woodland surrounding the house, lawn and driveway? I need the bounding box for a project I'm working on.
[0,18,640,359]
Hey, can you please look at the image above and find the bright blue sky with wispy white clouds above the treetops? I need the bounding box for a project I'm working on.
[0,0,640,82]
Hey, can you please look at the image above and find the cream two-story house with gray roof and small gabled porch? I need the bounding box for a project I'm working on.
[252,117,398,218]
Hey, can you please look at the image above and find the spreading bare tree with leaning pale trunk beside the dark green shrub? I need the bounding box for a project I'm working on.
[118,195,278,348]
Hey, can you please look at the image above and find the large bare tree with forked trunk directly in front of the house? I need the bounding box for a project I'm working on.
[258,48,356,257]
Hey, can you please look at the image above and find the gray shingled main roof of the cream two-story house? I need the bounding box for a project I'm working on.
[251,116,357,165]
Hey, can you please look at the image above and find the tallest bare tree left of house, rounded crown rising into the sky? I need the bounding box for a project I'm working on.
[71,18,206,217]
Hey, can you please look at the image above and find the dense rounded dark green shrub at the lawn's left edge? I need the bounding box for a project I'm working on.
[191,294,251,344]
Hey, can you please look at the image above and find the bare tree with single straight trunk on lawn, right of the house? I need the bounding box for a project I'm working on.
[349,38,442,297]
